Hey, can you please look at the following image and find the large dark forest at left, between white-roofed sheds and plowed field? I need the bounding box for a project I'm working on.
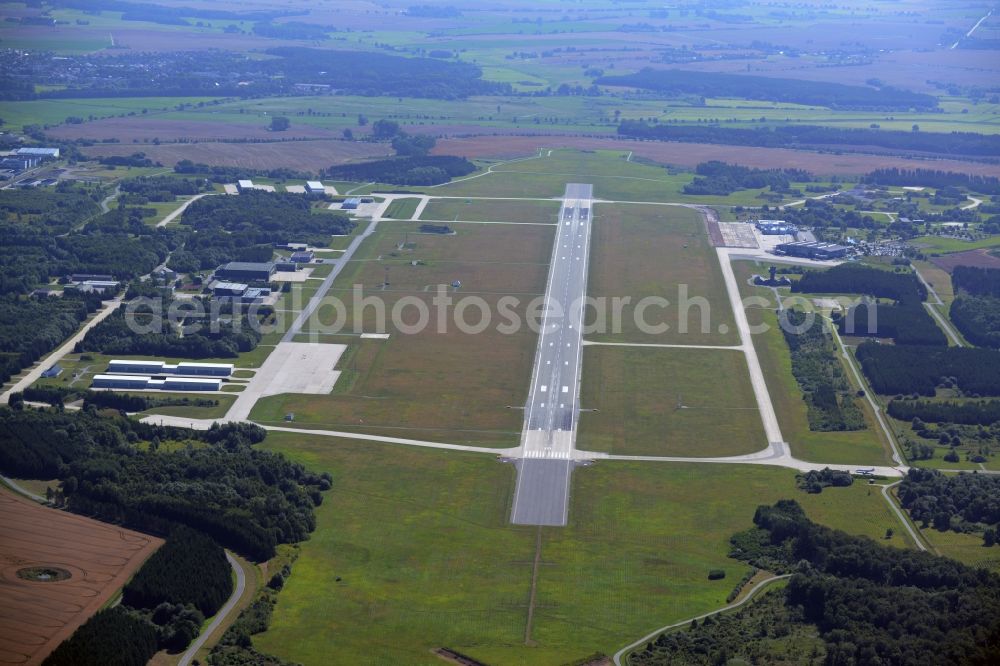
[0,408,331,560]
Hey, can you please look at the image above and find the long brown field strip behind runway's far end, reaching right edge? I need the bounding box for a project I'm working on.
[432,135,1000,176]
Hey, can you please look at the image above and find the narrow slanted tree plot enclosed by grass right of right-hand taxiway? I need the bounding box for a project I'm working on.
[781,310,865,431]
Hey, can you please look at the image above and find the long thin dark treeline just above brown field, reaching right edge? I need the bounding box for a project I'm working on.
[618,120,1000,157]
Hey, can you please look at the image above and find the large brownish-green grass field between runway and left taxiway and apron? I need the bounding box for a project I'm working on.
[252,222,553,446]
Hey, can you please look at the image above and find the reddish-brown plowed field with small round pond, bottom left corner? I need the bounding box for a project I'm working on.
[0,491,163,665]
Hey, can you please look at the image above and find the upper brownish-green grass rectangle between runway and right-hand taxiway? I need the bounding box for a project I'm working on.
[586,204,739,345]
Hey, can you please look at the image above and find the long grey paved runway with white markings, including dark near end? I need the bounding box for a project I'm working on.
[511,183,593,525]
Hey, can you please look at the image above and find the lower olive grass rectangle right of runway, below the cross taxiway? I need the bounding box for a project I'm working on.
[577,346,767,457]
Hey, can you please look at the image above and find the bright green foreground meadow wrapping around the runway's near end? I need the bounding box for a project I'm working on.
[254,433,916,666]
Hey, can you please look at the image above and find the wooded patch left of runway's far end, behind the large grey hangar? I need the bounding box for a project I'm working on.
[181,191,356,246]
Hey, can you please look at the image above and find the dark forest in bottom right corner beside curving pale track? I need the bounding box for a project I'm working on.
[630,500,1000,666]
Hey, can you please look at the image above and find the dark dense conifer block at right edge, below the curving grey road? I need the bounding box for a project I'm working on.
[856,342,1000,396]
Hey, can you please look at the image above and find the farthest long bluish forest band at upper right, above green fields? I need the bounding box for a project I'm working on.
[594,68,938,110]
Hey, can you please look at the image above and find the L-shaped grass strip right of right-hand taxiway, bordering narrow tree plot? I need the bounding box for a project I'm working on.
[733,261,892,465]
